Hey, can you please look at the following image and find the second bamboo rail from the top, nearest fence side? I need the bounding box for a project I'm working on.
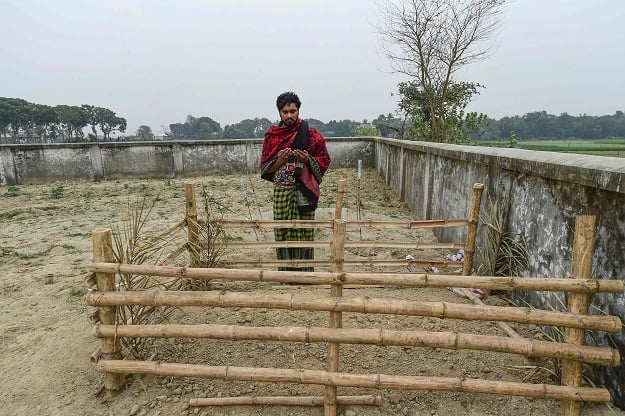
[87,290,622,332]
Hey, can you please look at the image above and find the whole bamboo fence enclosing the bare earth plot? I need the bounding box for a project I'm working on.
[85,181,623,416]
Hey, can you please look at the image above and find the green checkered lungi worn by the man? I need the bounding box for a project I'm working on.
[273,186,315,272]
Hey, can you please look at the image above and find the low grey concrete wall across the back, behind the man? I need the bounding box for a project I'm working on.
[0,138,374,186]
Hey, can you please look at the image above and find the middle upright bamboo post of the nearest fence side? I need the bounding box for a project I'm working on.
[323,219,346,416]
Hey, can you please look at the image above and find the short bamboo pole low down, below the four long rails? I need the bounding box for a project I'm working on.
[189,396,382,406]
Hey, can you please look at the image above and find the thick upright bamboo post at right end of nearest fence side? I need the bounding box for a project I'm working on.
[561,215,596,416]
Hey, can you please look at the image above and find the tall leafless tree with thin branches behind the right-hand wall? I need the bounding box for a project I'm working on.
[378,0,506,142]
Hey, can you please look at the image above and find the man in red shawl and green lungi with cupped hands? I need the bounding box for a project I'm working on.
[260,92,330,271]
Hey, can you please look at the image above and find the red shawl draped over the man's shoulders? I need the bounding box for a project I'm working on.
[260,118,330,174]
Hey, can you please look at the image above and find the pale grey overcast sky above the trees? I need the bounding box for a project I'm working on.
[0,0,625,134]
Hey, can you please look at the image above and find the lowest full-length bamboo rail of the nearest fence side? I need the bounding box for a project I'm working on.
[96,360,610,402]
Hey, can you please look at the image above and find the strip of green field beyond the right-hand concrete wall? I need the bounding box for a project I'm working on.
[476,139,625,157]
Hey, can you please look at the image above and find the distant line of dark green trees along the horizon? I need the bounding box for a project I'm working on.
[0,97,625,143]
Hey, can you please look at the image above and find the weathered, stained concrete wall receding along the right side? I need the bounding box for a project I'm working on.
[375,138,625,408]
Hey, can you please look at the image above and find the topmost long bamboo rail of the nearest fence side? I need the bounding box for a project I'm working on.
[88,261,624,293]
